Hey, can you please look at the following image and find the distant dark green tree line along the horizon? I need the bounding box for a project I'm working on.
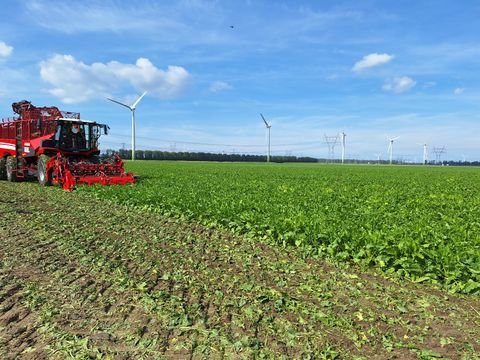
[106,149,480,166]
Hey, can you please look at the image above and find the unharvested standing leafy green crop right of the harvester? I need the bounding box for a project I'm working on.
[80,161,480,294]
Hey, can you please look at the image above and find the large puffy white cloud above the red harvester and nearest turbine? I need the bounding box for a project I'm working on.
[40,54,190,103]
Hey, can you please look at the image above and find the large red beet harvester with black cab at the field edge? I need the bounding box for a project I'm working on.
[0,100,135,191]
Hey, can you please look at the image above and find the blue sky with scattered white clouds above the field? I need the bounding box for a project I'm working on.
[0,0,480,161]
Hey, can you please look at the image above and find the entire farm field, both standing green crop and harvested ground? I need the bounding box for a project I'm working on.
[0,161,480,360]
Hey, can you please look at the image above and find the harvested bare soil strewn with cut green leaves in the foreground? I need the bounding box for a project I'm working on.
[0,182,480,359]
